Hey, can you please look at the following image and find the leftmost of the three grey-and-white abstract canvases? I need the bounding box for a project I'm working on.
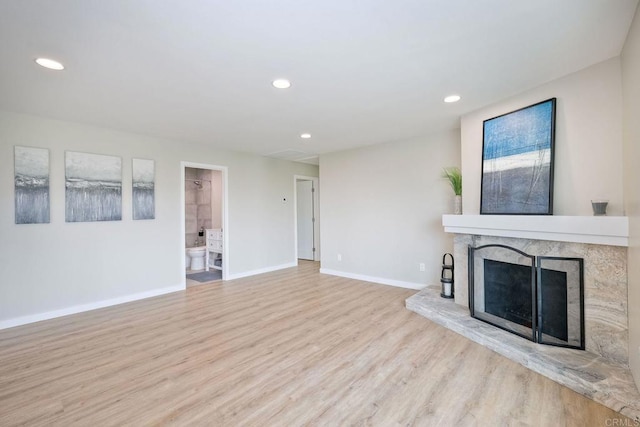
[14,146,50,224]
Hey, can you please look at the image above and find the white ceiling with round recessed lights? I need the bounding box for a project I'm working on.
[0,0,638,162]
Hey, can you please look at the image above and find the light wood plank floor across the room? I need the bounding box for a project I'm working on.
[0,262,634,427]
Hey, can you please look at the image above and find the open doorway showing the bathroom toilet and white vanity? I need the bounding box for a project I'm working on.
[181,162,229,286]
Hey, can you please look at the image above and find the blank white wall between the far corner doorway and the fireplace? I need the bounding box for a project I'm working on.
[320,131,460,288]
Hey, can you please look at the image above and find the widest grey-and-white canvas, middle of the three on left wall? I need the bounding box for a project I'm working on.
[65,151,122,222]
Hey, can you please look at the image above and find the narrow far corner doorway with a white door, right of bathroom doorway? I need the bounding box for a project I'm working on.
[294,175,320,261]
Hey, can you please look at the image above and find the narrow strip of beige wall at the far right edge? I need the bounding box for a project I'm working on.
[622,1,640,389]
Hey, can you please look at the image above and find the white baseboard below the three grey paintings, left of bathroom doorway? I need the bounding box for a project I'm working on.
[0,285,185,329]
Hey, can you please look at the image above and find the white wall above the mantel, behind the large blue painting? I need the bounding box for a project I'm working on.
[461,58,623,215]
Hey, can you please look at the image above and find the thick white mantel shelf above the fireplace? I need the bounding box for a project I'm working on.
[442,215,629,246]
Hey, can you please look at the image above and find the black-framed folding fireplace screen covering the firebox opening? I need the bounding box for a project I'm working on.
[468,244,585,350]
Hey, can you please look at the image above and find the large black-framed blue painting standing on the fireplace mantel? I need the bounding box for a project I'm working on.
[480,98,556,215]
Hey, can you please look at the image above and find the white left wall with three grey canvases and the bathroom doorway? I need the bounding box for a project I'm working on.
[0,112,318,327]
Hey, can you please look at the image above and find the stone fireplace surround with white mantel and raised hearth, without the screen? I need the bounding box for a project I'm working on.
[406,215,640,419]
